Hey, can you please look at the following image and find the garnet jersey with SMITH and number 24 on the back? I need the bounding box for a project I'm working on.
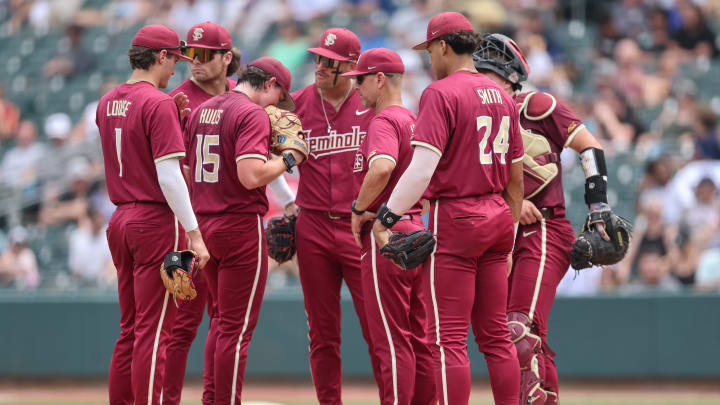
[411,70,523,199]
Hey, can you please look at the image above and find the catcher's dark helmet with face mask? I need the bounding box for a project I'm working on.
[473,34,530,91]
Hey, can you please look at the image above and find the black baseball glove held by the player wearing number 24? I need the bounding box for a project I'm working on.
[380,229,435,270]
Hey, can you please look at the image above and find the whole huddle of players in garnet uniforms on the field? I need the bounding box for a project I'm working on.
[96,12,628,405]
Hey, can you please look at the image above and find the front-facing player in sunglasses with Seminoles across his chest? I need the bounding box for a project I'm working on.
[293,28,386,404]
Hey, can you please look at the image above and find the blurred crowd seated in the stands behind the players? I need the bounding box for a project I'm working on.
[0,0,720,294]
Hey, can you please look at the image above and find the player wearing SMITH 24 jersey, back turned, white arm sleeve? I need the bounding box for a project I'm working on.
[373,12,523,405]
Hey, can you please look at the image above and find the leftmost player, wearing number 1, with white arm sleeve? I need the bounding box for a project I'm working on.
[96,25,209,404]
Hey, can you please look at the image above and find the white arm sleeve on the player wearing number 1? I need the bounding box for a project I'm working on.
[155,159,198,231]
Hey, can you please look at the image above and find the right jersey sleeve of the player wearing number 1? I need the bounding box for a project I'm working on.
[147,98,185,163]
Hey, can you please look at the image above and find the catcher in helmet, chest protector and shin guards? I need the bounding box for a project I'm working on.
[473,34,628,405]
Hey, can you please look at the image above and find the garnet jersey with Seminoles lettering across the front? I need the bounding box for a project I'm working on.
[292,84,375,213]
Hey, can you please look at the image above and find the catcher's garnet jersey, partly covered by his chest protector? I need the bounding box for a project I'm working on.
[515,93,585,207]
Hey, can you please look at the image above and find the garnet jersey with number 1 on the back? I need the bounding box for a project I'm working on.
[95,82,185,205]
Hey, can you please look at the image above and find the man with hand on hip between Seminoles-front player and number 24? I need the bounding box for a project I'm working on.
[343,48,436,405]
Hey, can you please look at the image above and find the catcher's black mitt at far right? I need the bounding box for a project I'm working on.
[570,209,632,270]
